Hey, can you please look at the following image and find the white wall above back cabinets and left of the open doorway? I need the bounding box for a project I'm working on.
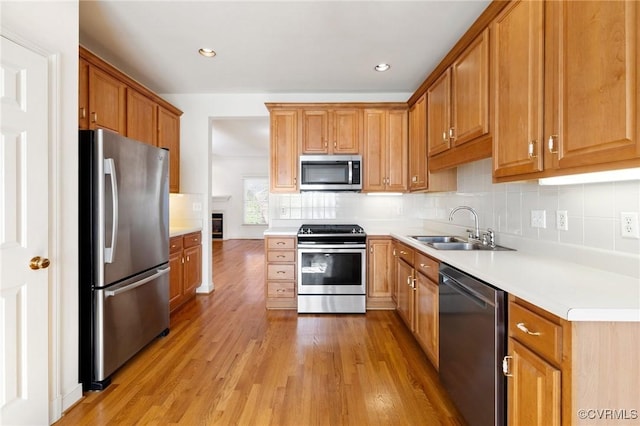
[162,93,411,288]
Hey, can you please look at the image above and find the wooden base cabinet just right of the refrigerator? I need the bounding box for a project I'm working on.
[169,232,202,312]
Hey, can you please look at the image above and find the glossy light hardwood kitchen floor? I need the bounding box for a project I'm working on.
[56,240,462,426]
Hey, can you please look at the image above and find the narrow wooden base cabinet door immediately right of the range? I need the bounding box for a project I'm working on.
[367,238,395,307]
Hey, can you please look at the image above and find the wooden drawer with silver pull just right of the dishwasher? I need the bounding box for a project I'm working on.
[509,302,562,364]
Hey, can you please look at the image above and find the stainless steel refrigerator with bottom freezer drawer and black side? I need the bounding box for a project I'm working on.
[78,130,169,390]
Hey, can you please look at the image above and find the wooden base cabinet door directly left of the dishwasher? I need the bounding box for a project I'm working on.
[414,273,438,368]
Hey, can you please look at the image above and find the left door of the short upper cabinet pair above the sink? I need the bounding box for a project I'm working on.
[427,68,451,156]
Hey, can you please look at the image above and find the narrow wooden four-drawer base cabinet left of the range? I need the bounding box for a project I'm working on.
[264,236,298,309]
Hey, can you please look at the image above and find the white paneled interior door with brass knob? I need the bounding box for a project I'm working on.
[0,37,49,425]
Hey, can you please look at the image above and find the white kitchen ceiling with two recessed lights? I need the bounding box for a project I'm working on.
[80,0,489,94]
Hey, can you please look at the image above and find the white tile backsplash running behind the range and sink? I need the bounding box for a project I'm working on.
[270,159,640,255]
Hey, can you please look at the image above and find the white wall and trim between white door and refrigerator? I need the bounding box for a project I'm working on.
[0,0,82,422]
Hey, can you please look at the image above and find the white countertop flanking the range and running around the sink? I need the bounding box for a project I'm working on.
[265,226,640,322]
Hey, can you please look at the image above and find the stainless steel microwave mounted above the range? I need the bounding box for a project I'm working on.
[300,155,362,191]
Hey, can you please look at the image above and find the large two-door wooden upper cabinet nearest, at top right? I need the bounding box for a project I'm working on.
[491,1,640,181]
